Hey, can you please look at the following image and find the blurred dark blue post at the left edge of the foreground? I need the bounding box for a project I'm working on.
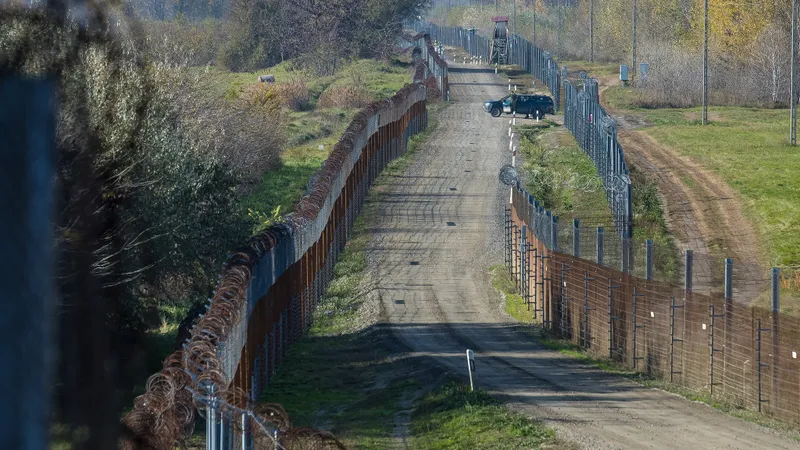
[0,75,56,450]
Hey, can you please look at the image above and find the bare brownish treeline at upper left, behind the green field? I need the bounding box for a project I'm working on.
[135,0,430,75]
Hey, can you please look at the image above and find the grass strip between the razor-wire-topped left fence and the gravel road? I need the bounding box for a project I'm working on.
[261,104,553,449]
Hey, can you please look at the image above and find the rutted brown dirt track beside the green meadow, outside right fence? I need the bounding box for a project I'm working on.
[600,77,769,304]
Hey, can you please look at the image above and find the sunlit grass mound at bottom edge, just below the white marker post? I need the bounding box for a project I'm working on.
[410,381,564,449]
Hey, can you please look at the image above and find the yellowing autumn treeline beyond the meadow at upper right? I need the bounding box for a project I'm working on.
[438,0,792,107]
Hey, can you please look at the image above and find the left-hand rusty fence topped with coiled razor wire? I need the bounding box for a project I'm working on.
[123,67,438,450]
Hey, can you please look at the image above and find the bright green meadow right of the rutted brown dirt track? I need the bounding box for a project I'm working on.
[606,87,800,315]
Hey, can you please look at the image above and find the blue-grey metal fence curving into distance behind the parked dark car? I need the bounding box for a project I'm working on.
[407,21,633,244]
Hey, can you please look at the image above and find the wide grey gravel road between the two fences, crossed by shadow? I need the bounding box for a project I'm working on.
[367,66,797,450]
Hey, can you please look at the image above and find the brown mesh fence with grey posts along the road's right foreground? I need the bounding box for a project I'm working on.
[505,182,800,424]
